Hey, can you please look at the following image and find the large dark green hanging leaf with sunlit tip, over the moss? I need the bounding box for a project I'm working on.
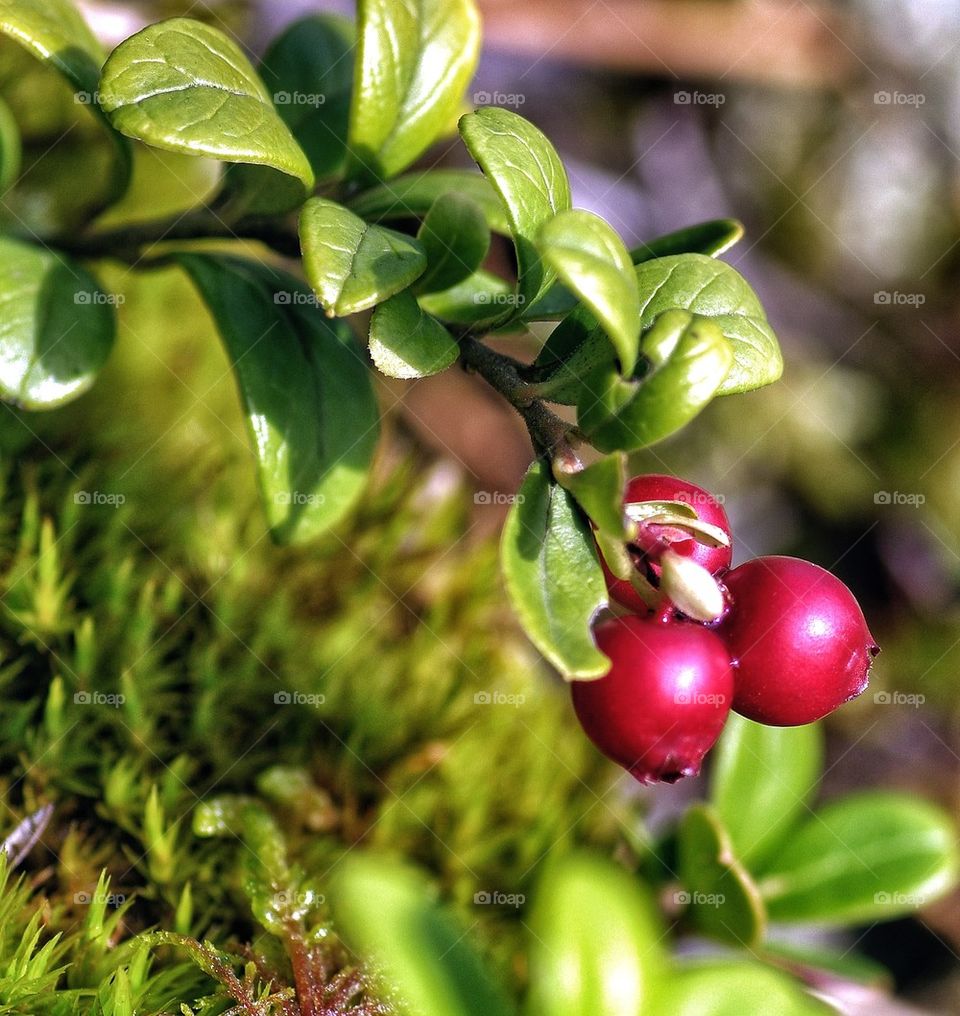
[177,254,379,543]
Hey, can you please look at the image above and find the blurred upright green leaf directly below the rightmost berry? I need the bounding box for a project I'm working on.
[710,713,823,871]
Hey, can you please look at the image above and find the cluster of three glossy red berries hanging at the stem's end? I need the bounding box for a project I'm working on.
[573,475,878,782]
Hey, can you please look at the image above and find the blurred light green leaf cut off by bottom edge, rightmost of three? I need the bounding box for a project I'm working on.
[650,960,835,1016]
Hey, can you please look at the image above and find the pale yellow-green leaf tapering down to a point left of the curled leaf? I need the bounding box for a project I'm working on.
[538,208,640,377]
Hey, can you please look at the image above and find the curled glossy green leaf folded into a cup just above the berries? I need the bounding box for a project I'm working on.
[577,311,733,452]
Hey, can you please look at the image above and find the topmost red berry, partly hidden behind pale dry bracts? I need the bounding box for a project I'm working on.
[600,473,732,614]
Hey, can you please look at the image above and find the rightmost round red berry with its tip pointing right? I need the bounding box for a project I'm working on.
[717,557,878,726]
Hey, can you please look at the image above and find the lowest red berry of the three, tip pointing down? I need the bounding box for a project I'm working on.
[573,616,733,783]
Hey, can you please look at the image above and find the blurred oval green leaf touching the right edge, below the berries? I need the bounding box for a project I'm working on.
[760,791,958,925]
